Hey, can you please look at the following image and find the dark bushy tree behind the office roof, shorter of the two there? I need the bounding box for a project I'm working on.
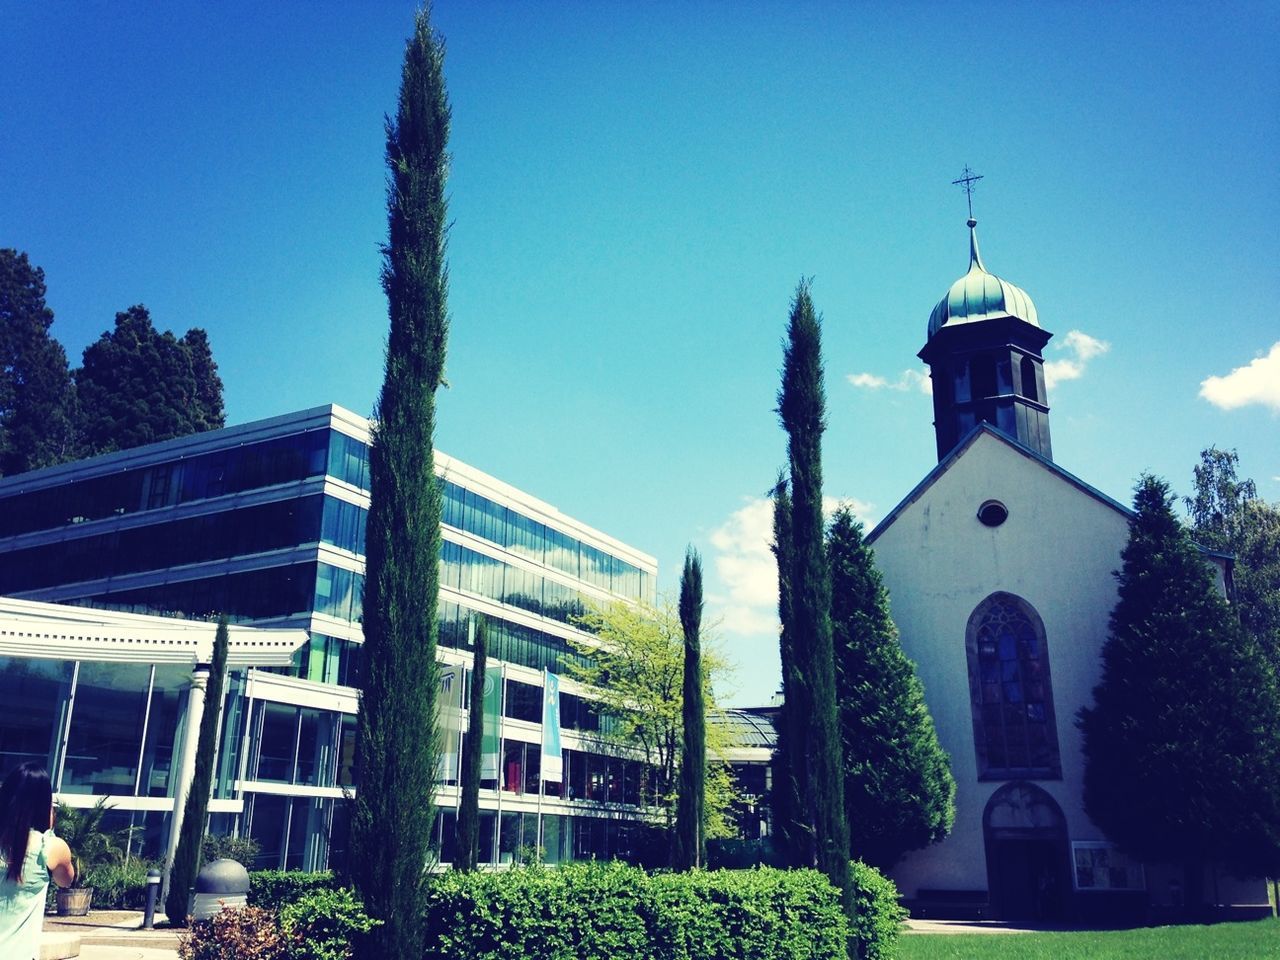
[76,305,223,454]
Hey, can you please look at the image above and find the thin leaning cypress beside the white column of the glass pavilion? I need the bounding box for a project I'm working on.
[164,617,230,925]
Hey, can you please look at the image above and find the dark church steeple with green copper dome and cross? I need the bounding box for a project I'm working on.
[919,211,1053,461]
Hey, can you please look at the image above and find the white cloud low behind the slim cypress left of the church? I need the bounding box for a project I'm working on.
[707,497,873,647]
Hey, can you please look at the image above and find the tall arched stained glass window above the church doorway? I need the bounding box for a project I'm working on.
[965,593,1062,780]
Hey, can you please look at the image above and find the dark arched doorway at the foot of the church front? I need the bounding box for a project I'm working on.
[982,782,1071,922]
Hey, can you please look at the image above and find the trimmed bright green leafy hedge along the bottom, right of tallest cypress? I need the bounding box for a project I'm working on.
[424,863,849,960]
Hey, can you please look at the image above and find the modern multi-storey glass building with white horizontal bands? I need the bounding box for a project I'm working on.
[0,406,657,869]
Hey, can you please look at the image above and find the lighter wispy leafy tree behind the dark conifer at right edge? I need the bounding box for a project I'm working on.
[1184,447,1280,669]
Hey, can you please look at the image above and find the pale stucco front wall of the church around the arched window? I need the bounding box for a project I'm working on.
[874,434,1129,897]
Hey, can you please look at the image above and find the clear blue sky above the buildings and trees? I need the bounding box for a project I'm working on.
[0,0,1280,703]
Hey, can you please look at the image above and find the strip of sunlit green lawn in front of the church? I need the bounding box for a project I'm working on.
[896,919,1280,960]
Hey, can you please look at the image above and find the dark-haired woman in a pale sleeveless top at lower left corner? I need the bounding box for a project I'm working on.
[0,763,76,960]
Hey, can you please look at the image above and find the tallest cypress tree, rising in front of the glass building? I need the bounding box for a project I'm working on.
[351,10,449,960]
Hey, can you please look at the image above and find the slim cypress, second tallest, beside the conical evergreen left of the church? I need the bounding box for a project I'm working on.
[778,280,854,915]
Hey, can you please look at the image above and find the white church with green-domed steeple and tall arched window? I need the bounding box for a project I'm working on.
[868,215,1267,922]
